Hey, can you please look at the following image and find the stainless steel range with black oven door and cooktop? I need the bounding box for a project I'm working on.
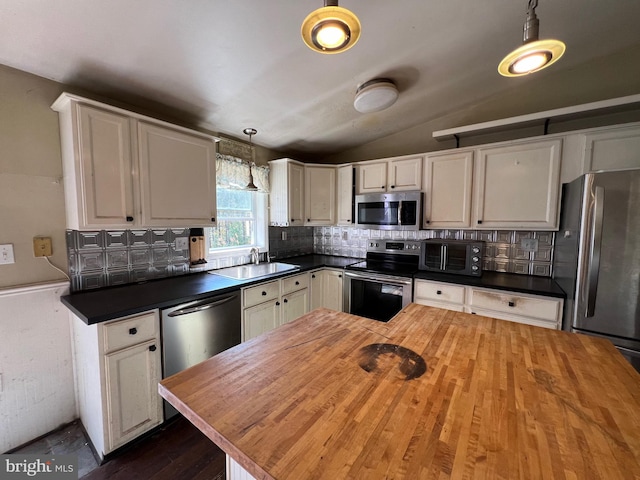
[344,240,420,322]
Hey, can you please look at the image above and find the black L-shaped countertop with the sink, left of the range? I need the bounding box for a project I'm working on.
[61,255,361,325]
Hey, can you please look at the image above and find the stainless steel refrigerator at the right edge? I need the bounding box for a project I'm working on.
[553,169,640,371]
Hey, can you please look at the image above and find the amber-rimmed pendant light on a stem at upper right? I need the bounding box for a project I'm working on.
[498,0,566,77]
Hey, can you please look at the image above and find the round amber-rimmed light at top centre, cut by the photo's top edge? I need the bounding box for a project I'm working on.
[300,0,361,53]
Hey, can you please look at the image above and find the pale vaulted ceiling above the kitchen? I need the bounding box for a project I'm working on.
[0,0,640,158]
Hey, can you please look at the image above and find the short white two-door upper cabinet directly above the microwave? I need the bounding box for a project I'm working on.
[356,155,423,194]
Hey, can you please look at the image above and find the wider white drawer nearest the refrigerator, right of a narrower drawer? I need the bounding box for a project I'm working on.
[467,288,562,322]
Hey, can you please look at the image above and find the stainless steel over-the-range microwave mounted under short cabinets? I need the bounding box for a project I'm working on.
[355,192,423,230]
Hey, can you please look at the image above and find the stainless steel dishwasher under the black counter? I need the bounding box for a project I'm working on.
[161,291,241,420]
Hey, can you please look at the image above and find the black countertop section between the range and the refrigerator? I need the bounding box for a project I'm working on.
[414,272,567,298]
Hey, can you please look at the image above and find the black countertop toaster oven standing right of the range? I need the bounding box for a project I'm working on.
[418,239,484,277]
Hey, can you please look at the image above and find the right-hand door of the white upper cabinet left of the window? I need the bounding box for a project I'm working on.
[138,122,216,227]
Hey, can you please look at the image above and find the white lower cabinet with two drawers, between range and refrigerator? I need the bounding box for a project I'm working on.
[414,279,564,330]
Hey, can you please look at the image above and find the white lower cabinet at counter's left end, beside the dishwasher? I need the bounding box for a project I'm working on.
[72,310,163,458]
